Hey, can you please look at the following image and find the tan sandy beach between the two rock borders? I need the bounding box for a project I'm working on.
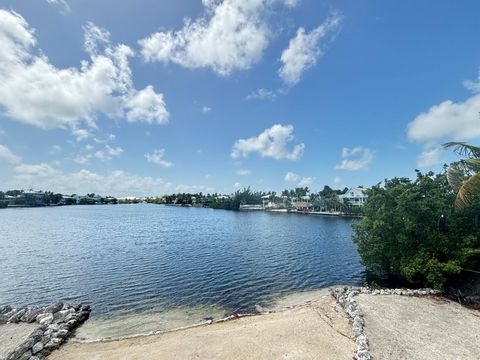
[49,296,355,360]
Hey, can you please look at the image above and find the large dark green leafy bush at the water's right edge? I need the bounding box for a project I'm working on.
[353,172,480,288]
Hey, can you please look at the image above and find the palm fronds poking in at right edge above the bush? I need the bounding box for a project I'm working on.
[443,142,480,209]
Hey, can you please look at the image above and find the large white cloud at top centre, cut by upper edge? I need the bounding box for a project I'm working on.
[139,0,297,76]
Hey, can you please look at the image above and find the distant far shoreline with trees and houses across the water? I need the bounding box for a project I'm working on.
[0,186,366,217]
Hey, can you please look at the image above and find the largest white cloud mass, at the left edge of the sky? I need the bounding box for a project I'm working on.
[0,10,168,129]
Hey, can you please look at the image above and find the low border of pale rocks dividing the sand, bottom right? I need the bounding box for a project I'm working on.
[331,286,441,360]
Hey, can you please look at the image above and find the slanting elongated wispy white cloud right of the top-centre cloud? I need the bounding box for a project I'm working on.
[278,12,342,86]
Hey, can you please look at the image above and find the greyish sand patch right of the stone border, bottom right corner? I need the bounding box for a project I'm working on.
[356,294,480,360]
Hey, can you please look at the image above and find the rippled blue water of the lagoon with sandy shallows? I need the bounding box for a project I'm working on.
[0,205,365,338]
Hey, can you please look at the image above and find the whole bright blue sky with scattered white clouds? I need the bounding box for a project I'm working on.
[0,0,480,196]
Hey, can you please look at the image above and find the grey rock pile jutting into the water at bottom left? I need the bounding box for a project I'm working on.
[0,302,90,360]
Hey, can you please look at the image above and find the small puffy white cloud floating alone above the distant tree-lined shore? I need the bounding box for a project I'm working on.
[231,124,305,160]
